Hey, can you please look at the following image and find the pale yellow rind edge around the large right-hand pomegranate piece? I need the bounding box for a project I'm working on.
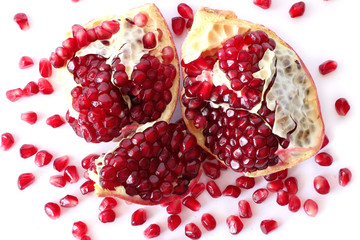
[180,7,325,177]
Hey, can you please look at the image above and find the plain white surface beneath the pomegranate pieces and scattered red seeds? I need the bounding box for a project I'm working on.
[0,0,360,240]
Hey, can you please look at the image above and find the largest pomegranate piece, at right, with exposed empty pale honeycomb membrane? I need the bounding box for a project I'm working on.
[180,8,324,177]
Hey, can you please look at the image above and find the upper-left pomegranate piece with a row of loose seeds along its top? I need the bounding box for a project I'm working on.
[55,4,179,143]
